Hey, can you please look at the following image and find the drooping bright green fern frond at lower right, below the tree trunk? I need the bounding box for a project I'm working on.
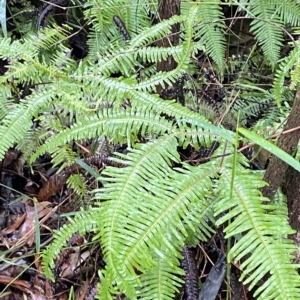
[215,165,300,300]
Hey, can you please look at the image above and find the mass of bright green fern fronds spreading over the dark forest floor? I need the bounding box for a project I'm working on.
[0,0,300,300]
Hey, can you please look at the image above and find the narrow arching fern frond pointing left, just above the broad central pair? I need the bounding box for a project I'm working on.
[29,109,173,162]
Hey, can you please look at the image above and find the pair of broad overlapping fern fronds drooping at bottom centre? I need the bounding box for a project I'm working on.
[97,136,218,299]
